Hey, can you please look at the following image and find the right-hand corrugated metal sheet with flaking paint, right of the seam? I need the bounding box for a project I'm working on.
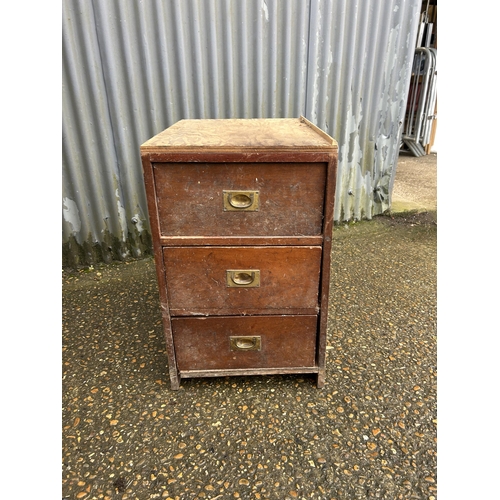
[306,0,421,221]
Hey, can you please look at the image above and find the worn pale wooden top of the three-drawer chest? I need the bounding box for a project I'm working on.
[141,116,338,153]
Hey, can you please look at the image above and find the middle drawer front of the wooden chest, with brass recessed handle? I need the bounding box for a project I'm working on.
[163,246,322,316]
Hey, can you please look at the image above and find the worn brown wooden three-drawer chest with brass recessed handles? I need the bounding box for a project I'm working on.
[141,117,338,389]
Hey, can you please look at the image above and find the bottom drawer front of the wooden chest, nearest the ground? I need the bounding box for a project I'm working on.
[172,316,317,371]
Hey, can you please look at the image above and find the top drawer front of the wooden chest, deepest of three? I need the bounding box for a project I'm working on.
[154,163,327,236]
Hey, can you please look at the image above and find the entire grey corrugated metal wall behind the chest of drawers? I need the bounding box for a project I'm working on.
[62,0,421,266]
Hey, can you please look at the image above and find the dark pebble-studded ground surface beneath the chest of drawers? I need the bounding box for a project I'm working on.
[62,212,437,500]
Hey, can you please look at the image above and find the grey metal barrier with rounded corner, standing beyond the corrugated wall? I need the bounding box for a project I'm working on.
[402,47,437,156]
